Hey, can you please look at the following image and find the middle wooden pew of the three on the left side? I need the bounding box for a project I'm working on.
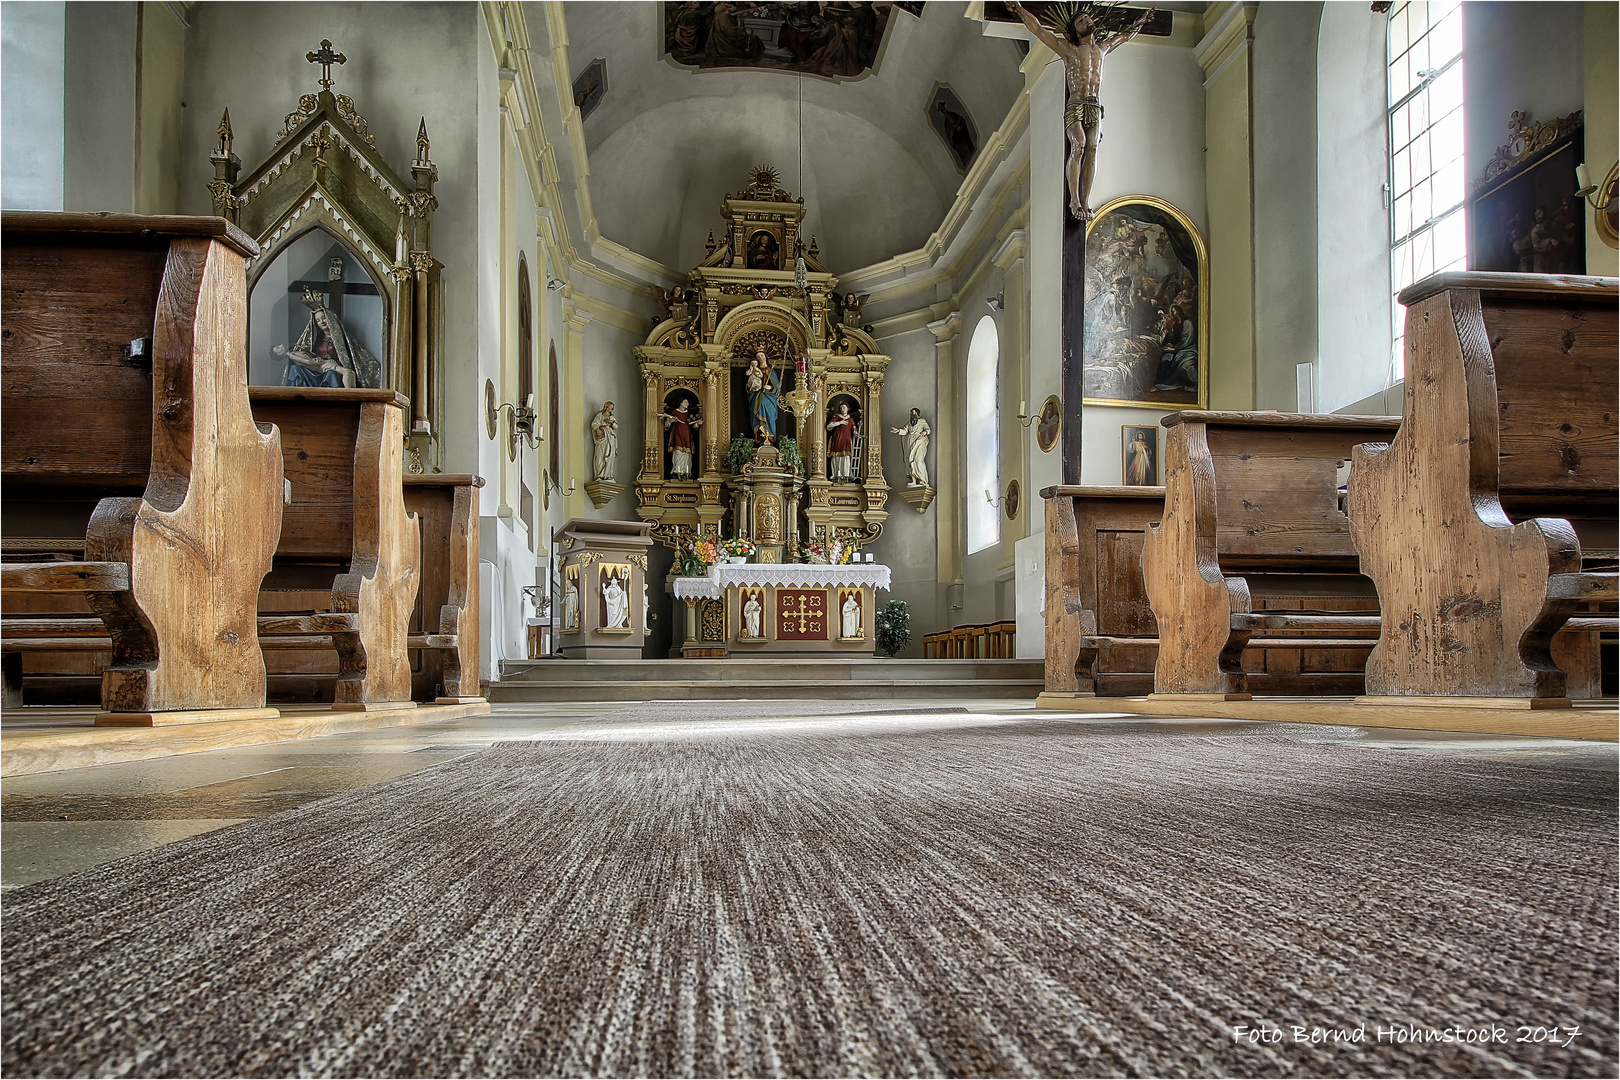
[248,387,421,711]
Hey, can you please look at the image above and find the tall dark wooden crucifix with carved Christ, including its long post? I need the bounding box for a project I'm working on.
[985,0,1173,484]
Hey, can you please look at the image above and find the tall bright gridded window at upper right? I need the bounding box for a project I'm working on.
[1387,0,1468,382]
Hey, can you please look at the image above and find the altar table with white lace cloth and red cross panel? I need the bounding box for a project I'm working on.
[674,563,889,659]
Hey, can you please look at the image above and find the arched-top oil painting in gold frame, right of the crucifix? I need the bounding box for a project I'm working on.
[1082,194,1209,410]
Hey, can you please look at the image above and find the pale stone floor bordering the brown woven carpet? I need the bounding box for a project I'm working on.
[0,699,1617,889]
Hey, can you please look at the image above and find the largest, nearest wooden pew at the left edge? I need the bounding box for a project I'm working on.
[0,212,282,725]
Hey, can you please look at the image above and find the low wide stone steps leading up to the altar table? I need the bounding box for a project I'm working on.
[488,657,1045,701]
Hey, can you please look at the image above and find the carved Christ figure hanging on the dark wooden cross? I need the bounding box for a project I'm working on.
[1008,0,1153,222]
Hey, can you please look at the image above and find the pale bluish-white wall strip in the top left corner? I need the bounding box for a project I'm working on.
[0,0,66,210]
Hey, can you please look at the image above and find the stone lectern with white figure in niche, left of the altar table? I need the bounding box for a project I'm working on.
[557,518,653,661]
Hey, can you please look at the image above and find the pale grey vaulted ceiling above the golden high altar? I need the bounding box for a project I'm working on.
[550,2,1024,272]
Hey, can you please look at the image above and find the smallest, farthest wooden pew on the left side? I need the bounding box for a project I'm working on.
[405,473,484,704]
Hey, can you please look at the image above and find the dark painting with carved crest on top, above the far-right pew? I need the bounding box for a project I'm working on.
[1468,112,1586,274]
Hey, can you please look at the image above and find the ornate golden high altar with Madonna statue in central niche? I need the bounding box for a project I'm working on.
[635,167,889,562]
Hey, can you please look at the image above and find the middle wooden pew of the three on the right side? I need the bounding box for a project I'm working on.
[1142,411,1398,699]
